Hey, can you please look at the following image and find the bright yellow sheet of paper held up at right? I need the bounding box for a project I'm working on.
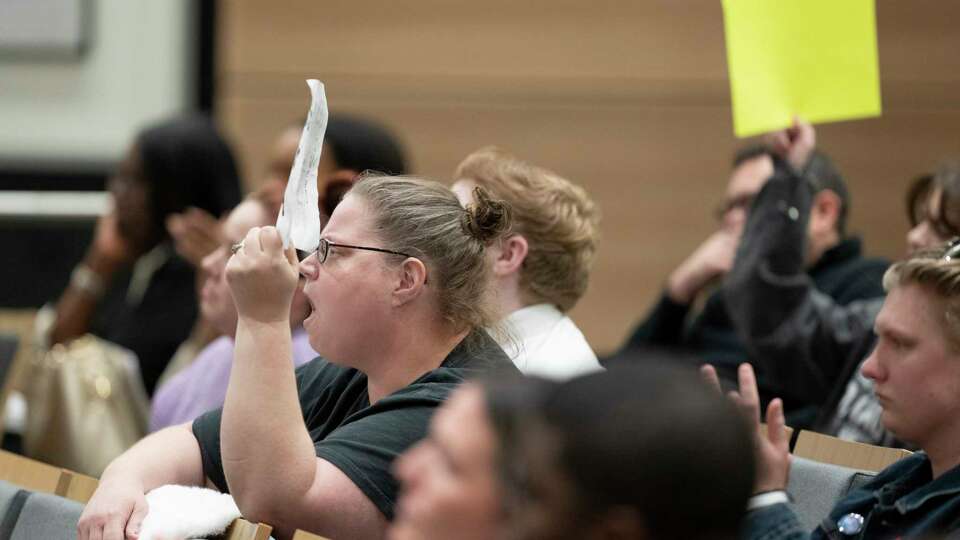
[723,0,880,137]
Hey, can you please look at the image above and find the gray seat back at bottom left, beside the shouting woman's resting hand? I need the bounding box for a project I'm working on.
[10,493,83,540]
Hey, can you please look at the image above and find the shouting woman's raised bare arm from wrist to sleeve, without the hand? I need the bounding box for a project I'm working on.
[220,321,386,539]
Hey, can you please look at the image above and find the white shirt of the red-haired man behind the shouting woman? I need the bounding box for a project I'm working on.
[497,304,603,380]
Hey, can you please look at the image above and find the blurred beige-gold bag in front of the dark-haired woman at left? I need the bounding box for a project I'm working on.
[24,334,150,477]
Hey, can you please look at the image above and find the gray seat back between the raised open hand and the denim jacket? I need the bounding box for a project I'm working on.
[787,456,875,530]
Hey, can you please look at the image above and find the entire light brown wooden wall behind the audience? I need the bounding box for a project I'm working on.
[217,0,960,352]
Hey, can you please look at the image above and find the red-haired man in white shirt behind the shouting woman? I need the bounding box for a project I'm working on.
[453,148,600,378]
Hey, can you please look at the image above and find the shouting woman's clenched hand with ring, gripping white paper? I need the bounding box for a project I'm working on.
[226,227,300,323]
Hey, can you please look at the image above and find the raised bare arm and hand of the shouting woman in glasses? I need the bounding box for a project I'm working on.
[220,227,386,538]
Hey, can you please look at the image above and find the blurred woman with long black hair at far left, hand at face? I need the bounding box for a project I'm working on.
[47,116,240,393]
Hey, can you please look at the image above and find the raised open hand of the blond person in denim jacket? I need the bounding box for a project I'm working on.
[700,364,790,493]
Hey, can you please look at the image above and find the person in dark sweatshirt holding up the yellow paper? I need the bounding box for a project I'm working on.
[724,122,960,445]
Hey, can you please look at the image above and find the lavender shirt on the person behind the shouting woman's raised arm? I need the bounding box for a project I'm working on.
[150,328,317,432]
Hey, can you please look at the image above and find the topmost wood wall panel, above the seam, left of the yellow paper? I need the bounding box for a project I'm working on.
[222,0,726,79]
